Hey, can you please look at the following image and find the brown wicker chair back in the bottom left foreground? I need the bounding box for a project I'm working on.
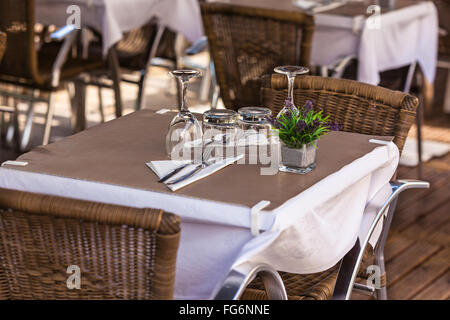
[0,189,180,300]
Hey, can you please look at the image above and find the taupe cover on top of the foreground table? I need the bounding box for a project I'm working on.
[5,110,392,209]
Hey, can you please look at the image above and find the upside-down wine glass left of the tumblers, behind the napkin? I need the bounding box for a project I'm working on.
[166,70,202,159]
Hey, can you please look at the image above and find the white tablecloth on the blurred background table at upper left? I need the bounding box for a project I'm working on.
[36,0,203,53]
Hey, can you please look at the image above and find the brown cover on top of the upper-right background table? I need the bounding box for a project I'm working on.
[224,0,420,17]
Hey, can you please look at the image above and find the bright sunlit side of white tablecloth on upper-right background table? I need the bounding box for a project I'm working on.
[358,1,439,84]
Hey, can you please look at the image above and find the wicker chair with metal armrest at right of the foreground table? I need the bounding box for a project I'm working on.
[251,74,427,299]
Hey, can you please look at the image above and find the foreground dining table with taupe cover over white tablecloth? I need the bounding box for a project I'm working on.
[0,110,399,299]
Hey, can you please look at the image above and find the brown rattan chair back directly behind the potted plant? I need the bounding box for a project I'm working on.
[261,74,419,152]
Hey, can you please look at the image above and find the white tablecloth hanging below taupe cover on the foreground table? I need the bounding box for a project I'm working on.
[0,143,398,299]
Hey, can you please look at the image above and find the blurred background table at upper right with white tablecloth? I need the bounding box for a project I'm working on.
[211,0,438,85]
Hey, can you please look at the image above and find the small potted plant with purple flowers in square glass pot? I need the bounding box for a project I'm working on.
[268,100,340,174]
